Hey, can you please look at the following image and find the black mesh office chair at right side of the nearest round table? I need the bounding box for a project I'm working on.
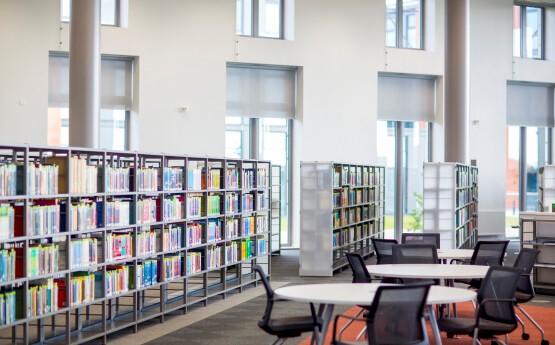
[438,266,522,344]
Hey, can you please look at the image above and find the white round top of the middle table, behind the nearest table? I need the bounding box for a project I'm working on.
[366,264,490,279]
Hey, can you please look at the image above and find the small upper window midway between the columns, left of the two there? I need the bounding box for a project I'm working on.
[236,0,284,38]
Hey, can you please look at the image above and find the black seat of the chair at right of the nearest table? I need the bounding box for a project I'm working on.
[437,317,515,338]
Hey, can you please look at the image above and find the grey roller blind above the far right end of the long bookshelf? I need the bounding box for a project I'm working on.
[226,65,296,119]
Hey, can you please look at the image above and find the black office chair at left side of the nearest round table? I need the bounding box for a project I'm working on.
[253,265,324,345]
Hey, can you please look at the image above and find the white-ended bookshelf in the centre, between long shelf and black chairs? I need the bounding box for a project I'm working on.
[299,162,385,276]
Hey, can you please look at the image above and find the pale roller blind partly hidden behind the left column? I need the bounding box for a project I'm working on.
[48,54,133,110]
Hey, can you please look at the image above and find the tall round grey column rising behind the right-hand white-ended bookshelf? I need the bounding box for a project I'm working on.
[445,0,469,164]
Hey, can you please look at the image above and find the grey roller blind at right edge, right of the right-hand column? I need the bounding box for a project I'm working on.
[507,83,555,127]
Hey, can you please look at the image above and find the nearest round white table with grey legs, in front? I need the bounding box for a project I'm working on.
[274,283,476,345]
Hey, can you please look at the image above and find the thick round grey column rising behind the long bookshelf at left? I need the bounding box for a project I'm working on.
[69,0,100,148]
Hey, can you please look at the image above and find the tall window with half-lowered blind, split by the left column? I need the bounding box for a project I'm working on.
[47,54,133,150]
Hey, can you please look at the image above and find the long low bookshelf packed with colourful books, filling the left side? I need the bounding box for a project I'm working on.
[0,146,271,344]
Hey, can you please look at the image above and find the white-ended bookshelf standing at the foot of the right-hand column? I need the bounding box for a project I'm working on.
[423,163,478,249]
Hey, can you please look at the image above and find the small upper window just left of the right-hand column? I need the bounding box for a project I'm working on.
[385,0,423,49]
